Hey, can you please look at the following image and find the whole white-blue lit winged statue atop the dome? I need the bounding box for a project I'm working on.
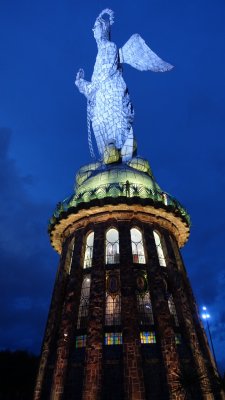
[75,8,173,161]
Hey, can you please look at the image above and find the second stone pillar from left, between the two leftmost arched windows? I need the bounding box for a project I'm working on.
[50,230,83,400]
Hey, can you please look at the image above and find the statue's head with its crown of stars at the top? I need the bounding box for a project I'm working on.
[93,8,114,40]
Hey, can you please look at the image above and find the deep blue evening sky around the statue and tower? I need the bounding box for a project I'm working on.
[0,0,225,371]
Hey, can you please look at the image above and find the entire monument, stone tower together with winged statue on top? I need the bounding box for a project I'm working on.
[34,9,223,400]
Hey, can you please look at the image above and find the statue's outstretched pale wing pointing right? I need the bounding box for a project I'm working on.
[119,33,173,72]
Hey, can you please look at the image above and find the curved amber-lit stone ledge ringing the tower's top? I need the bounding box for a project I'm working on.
[48,197,190,253]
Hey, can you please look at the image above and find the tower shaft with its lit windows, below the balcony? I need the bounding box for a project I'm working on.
[34,205,222,400]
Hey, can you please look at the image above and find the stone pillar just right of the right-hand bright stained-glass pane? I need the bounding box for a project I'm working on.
[144,225,185,400]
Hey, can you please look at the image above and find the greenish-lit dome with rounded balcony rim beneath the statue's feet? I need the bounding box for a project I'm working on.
[49,157,190,251]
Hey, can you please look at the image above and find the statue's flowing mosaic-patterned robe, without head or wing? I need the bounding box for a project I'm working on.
[83,41,134,156]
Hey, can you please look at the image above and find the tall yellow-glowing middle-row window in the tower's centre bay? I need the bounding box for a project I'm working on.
[105,271,121,326]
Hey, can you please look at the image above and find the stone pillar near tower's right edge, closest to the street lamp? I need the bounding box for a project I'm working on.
[164,235,214,400]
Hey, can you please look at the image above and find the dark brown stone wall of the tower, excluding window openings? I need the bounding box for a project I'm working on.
[34,210,223,400]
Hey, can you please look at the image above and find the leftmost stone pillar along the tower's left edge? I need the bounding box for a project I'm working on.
[34,239,70,400]
